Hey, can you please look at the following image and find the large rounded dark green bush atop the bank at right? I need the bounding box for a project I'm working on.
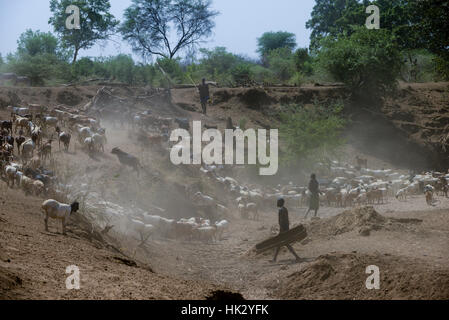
[318,27,401,94]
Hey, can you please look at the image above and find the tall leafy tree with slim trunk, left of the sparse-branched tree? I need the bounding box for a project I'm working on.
[48,0,119,63]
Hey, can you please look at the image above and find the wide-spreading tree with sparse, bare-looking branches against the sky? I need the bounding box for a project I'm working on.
[120,0,218,59]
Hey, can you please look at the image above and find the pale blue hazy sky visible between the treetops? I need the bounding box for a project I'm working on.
[0,0,315,58]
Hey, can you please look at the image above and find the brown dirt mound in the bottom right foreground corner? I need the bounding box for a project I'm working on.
[275,253,449,300]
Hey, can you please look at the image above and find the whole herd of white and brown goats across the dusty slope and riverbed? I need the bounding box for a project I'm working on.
[0,104,449,241]
